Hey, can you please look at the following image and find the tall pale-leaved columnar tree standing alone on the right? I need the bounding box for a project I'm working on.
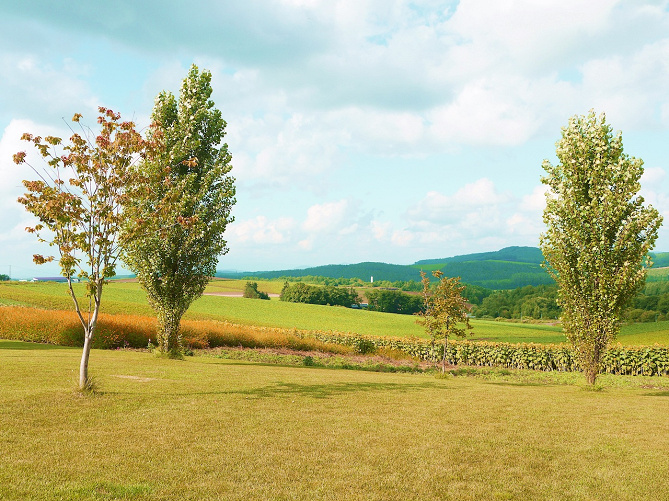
[540,111,662,384]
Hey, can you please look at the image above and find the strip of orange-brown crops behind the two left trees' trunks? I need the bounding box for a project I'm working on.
[0,306,351,353]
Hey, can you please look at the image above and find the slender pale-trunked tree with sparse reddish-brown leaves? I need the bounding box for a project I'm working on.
[14,107,160,390]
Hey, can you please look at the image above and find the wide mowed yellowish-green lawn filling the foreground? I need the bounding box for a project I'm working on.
[0,341,669,501]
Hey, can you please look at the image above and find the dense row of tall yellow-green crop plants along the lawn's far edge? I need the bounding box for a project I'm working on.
[302,332,669,376]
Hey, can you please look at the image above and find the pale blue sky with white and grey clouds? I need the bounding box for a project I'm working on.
[0,0,669,278]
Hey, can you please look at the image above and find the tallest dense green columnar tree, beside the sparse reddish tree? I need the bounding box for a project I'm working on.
[123,65,235,357]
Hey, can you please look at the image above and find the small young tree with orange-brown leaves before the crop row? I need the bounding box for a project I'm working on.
[418,270,472,372]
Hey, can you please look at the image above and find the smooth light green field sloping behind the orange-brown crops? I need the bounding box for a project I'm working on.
[0,280,669,346]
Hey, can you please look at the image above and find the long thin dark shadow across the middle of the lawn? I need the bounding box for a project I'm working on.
[229,382,447,398]
